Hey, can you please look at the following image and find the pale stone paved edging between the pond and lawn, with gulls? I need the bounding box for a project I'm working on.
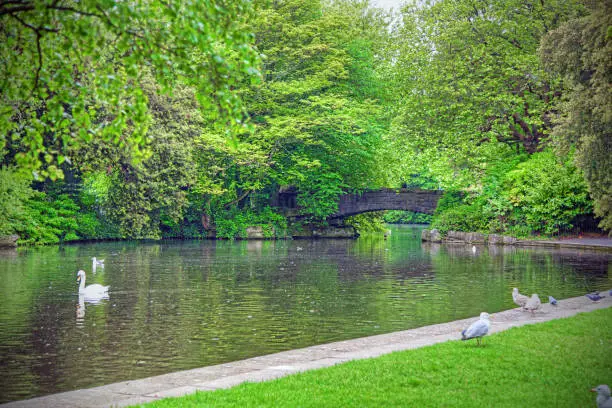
[2,294,612,408]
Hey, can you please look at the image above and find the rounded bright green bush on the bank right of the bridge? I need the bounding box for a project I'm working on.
[432,151,592,238]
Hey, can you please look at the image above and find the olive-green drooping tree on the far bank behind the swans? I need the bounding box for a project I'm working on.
[73,76,205,238]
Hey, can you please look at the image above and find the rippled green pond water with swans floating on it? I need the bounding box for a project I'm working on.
[0,226,612,402]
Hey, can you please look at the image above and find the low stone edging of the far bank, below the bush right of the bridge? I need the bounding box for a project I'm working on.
[421,229,612,252]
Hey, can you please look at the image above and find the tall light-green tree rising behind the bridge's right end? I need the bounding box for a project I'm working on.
[393,0,580,187]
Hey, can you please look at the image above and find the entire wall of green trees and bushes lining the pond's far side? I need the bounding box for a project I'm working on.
[0,0,612,243]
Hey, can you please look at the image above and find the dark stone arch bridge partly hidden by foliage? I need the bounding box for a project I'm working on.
[273,188,443,219]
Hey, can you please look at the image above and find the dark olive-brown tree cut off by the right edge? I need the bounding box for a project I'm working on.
[540,0,612,230]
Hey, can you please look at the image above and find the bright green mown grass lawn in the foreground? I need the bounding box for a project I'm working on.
[135,308,612,408]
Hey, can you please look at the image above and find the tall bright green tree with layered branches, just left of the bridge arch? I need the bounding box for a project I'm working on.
[230,0,387,218]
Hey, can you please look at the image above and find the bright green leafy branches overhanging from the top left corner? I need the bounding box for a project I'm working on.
[0,0,259,177]
